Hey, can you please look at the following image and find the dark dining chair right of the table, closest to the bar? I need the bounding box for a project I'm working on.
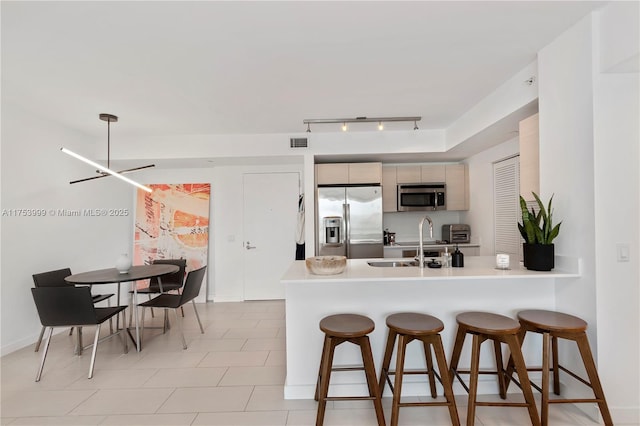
[138,266,207,349]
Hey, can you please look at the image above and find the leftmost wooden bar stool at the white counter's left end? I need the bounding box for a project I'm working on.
[315,314,385,426]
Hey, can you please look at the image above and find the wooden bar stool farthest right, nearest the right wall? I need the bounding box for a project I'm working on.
[507,310,613,426]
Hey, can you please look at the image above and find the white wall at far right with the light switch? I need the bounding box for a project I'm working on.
[594,2,640,424]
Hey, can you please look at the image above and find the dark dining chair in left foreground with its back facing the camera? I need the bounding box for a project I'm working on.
[31,286,129,382]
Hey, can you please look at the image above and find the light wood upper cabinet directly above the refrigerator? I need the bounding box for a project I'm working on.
[316,163,382,185]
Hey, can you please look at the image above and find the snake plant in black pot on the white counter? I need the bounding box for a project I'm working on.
[518,192,562,271]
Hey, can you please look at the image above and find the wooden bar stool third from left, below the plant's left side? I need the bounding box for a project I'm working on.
[451,312,540,426]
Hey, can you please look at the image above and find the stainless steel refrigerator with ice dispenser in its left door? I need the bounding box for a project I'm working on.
[316,186,384,259]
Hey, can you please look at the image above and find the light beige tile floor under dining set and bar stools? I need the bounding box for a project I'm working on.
[0,301,598,426]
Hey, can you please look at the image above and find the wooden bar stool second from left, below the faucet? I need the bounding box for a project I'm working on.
[379,312,460,426]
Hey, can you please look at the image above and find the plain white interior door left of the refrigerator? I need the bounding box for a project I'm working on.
[243,173,300,300]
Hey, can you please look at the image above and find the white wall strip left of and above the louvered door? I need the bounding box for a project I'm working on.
[460,137,520,256]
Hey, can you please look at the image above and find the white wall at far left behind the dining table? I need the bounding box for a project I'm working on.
[0,104,133,354]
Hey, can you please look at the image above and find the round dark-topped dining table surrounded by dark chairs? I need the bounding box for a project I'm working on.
[64,264,180,352]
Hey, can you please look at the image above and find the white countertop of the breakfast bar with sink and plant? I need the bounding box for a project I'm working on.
[281,256,580,284]
